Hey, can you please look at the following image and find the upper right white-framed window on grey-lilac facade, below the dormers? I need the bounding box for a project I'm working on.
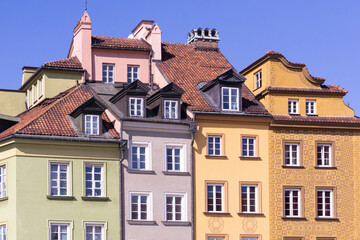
[166,146,185,171]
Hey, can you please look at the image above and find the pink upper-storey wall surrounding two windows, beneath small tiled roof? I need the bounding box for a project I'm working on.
[91,49,150,83]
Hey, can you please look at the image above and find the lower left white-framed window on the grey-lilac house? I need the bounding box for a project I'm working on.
[130,193,151,220]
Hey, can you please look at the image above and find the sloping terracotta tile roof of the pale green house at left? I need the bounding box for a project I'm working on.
[0,84,119,139]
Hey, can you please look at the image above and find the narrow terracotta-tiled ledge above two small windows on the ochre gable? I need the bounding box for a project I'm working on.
[256,84,348,99]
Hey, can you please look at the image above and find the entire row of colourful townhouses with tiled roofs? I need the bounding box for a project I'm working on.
[0,12,360,240]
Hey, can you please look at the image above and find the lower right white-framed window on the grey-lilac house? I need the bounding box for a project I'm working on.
[166,194,186,221]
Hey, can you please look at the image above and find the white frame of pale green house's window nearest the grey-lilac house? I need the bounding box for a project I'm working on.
[84,163,105,197]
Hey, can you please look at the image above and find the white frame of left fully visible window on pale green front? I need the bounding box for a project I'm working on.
[49,162,70,196]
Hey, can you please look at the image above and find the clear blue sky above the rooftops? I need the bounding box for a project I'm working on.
[0,0,360,115]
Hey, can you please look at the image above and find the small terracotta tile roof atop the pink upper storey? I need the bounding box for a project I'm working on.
[91,36,152,51]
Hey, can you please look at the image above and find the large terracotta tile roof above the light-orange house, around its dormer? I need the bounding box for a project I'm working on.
[157,43,267,114]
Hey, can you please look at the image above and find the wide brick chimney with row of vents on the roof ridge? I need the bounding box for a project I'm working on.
[187,28,220,48]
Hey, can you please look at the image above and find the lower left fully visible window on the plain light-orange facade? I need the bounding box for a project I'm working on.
[206,184,225,212]
